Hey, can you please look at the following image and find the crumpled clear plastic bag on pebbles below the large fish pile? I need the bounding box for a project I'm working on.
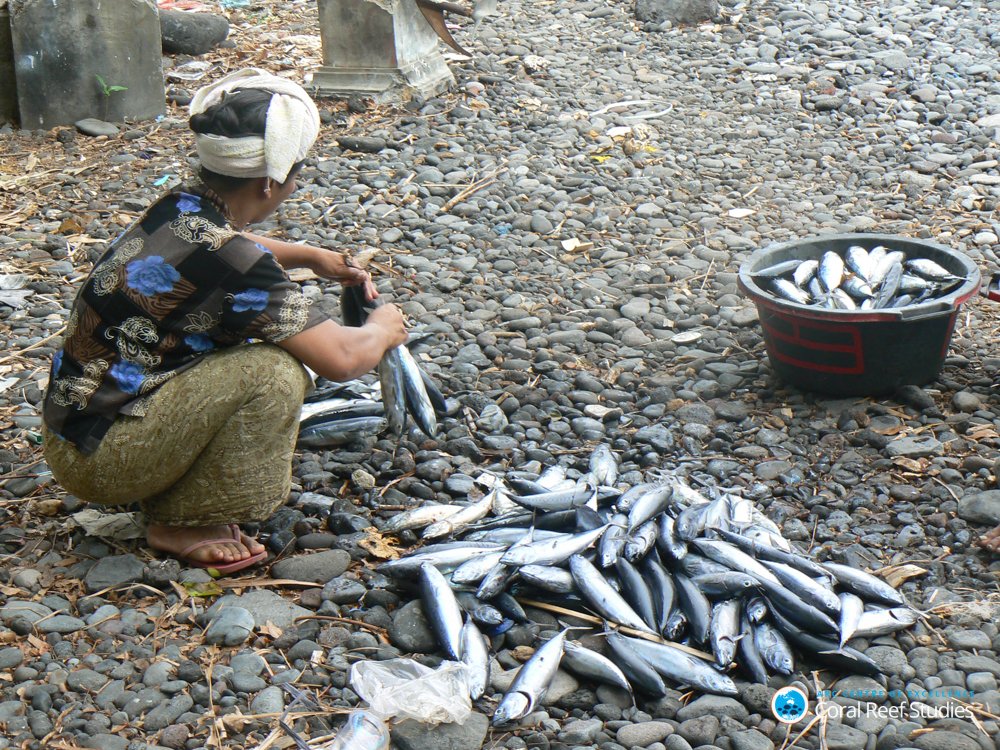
[351,659,472,724]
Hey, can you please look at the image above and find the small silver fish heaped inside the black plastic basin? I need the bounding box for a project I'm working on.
[753,245,965,310]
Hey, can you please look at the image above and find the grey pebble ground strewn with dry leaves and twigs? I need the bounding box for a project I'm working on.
[0,0,1000,750]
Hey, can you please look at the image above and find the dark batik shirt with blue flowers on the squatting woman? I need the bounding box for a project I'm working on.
[43,190,326,454]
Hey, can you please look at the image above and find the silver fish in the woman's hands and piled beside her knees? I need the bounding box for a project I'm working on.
[298,286,447,448]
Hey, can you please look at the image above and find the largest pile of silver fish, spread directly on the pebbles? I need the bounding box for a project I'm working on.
[379,445,919,726]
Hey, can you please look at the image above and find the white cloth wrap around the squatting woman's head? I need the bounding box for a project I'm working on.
[190,68,319,183]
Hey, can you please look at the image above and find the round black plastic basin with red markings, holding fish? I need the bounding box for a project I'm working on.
[739,234,980,396]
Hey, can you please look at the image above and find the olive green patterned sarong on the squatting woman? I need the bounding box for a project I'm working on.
[43,344,309,526]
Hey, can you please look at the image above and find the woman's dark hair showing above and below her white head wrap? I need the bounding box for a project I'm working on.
[188,89,302,192]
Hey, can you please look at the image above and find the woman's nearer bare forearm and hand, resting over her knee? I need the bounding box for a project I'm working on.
[278,305,407,382]
